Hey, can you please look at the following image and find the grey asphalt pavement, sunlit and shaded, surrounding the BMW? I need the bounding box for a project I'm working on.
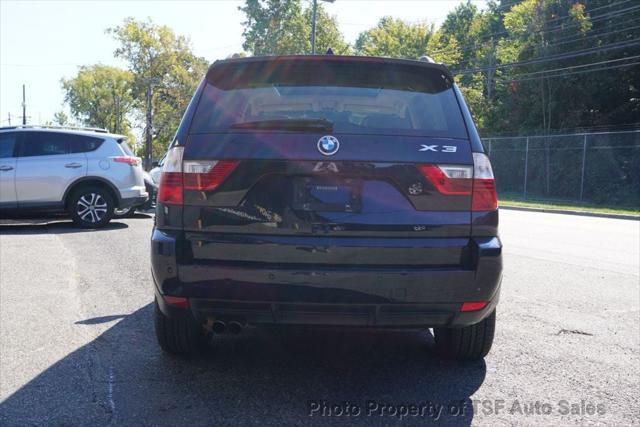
[0,210,640,426]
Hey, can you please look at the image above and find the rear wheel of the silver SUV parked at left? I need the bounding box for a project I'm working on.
[67,186,115,228]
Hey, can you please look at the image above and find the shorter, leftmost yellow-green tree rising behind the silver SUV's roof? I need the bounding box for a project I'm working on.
[61,65,135,133]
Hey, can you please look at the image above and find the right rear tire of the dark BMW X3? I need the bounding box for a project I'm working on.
[433,310,496,360]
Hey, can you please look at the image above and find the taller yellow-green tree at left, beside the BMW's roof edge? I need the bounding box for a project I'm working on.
[107,18,208,167]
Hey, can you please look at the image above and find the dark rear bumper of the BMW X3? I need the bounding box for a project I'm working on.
[151,229,502,327]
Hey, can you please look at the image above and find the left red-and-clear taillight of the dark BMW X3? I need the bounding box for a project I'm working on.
[158,147,239,205]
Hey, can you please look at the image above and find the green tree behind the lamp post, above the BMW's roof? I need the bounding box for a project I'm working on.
[239,0,350,56]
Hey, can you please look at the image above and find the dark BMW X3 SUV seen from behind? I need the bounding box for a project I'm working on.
[151,55,502,359]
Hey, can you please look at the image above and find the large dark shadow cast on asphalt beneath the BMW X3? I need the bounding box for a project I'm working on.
[0,304,486,426]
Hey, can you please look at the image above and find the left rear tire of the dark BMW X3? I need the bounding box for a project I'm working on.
[154,302,205,355]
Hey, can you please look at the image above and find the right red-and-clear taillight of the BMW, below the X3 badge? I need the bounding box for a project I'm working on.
[418,153,498,212]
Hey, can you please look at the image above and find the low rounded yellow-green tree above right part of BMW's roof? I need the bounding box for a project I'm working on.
[356,16,433,59]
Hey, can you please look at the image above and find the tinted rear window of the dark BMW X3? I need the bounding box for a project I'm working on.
[190,60,467,138]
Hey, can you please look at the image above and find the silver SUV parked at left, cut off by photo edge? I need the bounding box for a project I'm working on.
[0,126,148,228]
